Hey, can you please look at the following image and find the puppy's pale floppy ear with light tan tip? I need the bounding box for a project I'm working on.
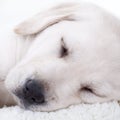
[14,3,78,35]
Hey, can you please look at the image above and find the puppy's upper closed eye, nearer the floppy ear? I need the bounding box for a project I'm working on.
[60,38,68,58]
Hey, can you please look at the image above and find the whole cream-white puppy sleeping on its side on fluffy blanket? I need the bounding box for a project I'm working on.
[0,3,120,111]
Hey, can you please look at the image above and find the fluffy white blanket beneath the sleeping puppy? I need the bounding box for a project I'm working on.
[0,101,120,120]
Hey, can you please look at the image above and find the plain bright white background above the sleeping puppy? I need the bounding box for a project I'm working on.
[0,0,120,27]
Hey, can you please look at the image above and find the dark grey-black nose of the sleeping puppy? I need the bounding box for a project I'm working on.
[22,80,45,104]
